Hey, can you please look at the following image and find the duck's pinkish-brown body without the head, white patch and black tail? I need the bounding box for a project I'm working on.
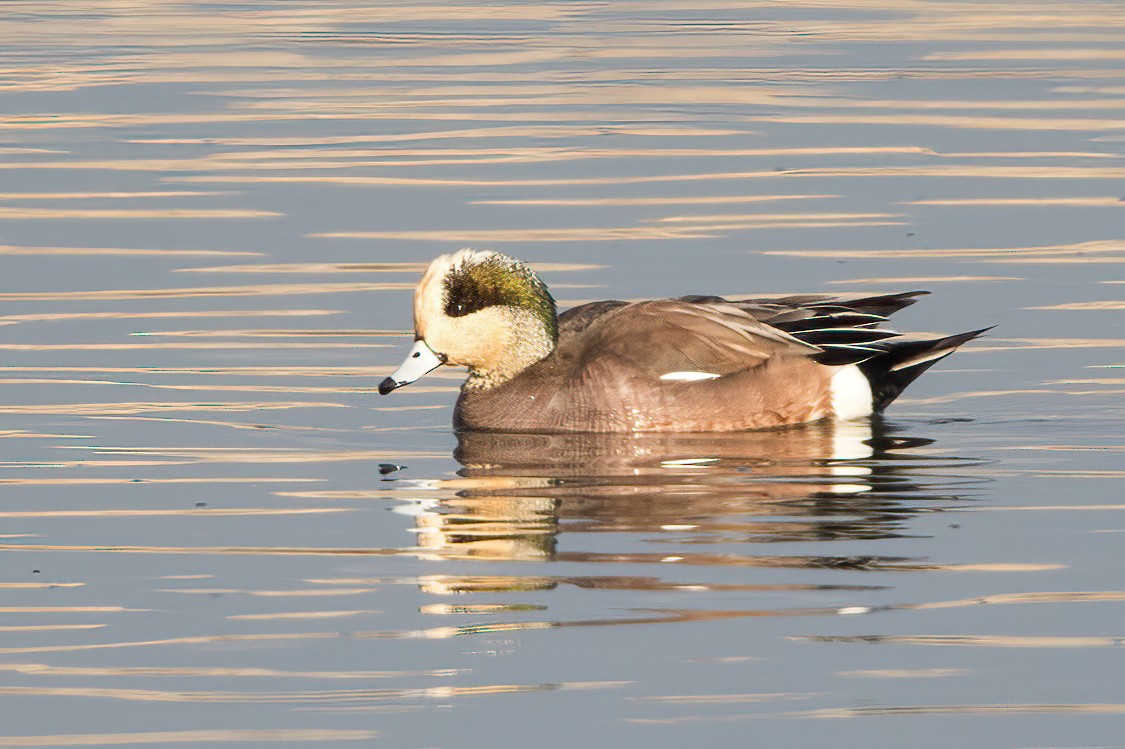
[453,299,838,432]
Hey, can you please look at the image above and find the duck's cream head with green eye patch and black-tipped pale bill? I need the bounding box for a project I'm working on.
[379,250,558,395]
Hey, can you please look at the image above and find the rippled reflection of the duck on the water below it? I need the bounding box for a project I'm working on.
[402,422,976,575]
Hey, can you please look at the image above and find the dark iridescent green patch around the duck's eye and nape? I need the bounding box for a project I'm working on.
[444,254,558,341]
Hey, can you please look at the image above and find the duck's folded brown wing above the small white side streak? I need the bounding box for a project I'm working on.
[571,299,822,380]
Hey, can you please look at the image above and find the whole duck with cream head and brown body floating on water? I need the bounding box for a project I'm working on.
[378,249,991,433]
